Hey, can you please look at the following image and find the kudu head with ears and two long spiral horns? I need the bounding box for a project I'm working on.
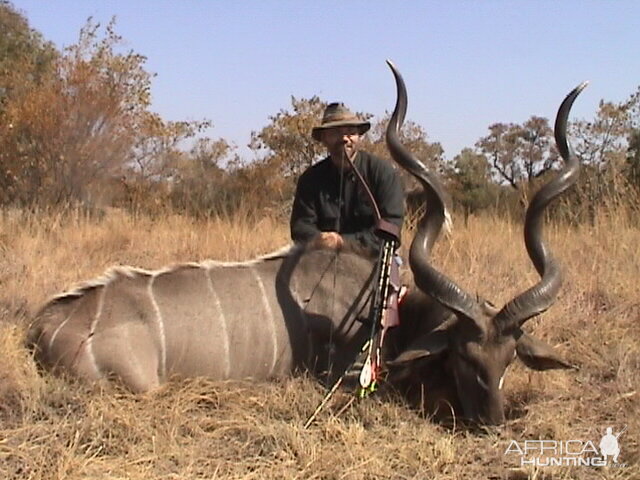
[386,62,586,425]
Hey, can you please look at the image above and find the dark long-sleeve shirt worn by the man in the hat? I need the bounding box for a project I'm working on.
[290,152,404,253]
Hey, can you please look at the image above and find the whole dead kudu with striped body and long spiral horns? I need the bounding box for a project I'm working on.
[28,62,582,424]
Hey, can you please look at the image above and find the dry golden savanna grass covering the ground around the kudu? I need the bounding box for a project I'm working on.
[0,207,640,479]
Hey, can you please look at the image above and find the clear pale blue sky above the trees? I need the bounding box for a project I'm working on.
[12,0,640,158]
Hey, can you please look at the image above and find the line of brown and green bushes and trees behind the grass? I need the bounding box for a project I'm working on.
[0,0,640,221]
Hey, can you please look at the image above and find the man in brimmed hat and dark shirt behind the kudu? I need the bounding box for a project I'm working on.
[290,103,404,251]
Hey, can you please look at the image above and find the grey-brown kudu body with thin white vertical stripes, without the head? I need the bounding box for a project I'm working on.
[29,247,374,391]
